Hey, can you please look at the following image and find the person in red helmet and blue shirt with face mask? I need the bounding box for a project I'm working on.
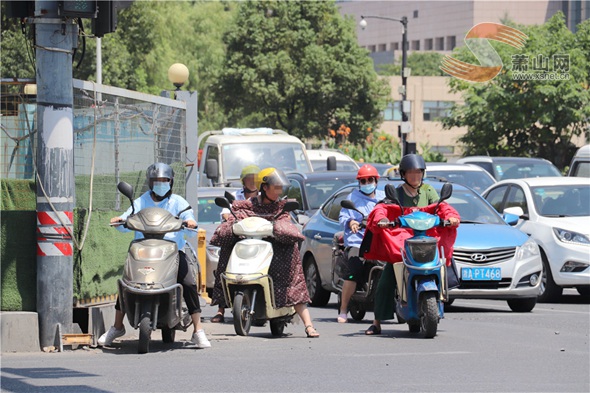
[337,164,385,323]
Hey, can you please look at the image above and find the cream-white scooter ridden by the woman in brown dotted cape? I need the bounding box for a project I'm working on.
[215,197,299,336]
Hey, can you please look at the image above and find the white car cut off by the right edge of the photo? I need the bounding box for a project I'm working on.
[483,177,590,301]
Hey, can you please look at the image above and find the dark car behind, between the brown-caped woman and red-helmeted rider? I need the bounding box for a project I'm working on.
[287,171,356,225]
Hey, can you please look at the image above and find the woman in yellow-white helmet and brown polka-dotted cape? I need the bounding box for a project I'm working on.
[210,168,319,337]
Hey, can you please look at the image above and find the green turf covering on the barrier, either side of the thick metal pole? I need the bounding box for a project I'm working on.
[0,179,133,311]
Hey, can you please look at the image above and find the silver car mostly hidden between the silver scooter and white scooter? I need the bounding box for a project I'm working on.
[197,187,239,288]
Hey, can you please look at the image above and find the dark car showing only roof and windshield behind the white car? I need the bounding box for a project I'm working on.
[457,156,561,181]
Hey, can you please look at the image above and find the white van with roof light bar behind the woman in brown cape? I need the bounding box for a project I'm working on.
[197,128,313,187]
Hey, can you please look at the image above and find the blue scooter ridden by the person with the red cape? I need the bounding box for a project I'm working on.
[385,183,453,338]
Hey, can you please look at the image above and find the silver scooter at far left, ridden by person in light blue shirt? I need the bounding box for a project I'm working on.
[111,182,196,353]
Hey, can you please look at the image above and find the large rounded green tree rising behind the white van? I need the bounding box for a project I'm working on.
[216,0,389,140]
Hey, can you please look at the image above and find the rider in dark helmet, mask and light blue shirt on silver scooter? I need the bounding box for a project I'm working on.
[98,162,211,348]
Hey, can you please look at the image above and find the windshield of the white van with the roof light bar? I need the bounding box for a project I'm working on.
[223,143,312,179]
